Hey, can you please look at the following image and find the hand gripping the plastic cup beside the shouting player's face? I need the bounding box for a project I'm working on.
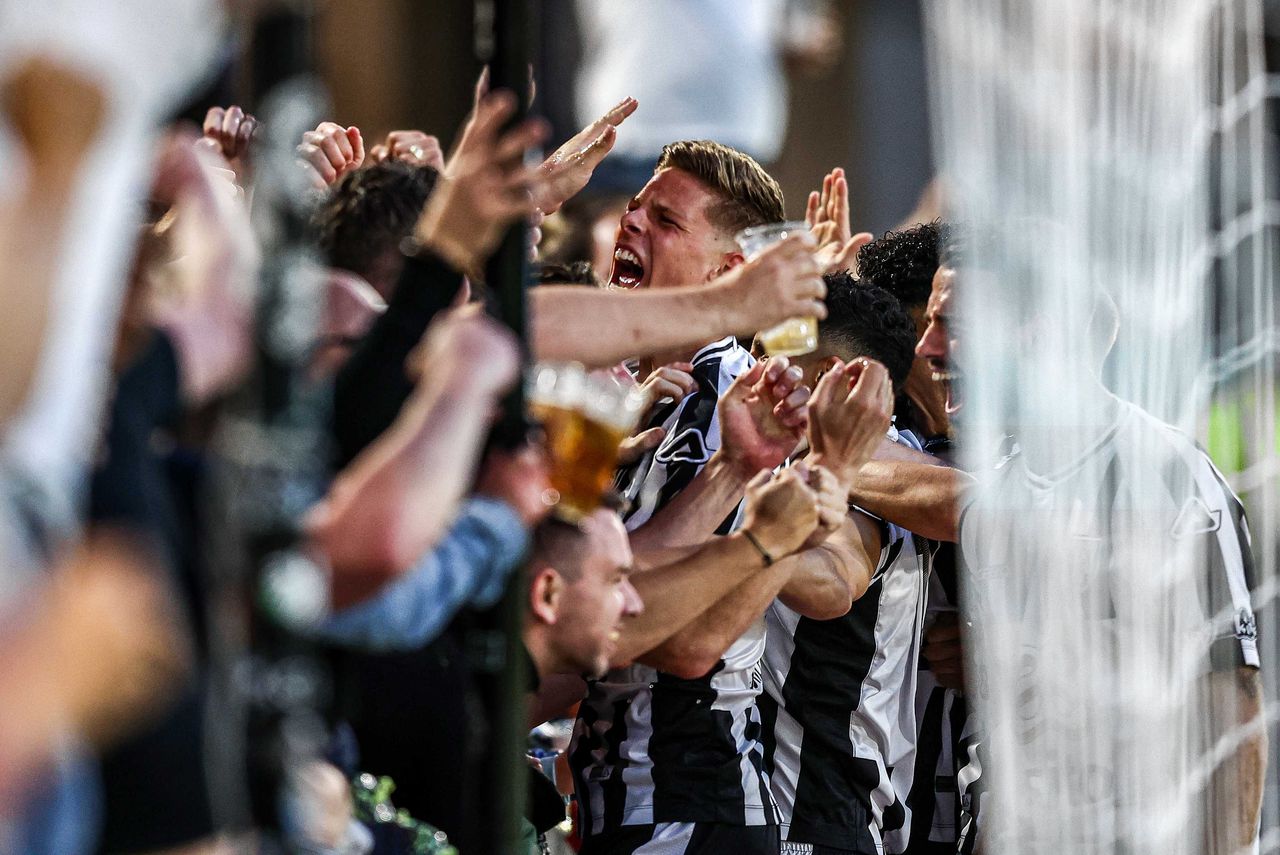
[716,234,827,335]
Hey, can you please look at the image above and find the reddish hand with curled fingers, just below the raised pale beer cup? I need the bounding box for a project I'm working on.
[716,356,809,475]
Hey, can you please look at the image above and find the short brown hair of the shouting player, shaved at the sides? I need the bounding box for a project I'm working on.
[657,140,786,233]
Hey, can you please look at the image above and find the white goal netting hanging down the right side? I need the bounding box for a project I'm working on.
[927,0,1280,855]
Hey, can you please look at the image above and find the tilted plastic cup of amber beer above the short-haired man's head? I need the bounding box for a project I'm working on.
[529,362,646,521]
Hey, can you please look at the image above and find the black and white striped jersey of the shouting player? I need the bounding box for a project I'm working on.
[570,337,777,837]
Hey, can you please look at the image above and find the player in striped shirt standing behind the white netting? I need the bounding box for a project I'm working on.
[916,234,1266,852]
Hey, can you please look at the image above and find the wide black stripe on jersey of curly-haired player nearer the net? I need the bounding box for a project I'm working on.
[782,578,885,855]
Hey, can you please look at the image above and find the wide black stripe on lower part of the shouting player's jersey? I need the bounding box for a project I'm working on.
[650,659,773,827]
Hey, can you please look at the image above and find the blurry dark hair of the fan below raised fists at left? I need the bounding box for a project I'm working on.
[311,160,439,293]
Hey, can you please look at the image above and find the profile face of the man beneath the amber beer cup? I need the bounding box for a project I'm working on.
[556,511,644,677]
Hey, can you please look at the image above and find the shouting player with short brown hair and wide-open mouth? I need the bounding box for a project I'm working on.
[571,142,887,855]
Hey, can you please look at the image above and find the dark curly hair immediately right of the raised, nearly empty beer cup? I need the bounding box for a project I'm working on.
[818,271,915,389]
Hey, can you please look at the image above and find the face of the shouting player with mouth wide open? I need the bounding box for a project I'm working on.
[609,168,742,288]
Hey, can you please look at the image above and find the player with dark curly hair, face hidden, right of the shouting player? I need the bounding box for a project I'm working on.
[759,273,931,855]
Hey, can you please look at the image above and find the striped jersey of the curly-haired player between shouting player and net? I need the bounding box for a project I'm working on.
[759,431,931,855]
